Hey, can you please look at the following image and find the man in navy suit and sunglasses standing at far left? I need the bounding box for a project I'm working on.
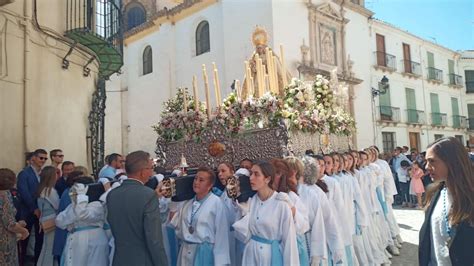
[17,149,48,264]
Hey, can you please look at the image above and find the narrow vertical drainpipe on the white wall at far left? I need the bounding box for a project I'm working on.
[23,1,30,154]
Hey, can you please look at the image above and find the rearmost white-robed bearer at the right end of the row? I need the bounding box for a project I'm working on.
[372,146,403,248]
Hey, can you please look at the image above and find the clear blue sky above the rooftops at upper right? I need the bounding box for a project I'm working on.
[365,0,474,50]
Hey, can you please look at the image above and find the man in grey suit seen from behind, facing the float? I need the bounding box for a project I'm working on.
[107,151,168,266]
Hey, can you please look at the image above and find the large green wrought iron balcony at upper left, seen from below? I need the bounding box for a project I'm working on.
[65,0,123,78]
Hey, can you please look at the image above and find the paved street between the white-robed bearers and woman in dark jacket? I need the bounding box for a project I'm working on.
[392,207,424,266]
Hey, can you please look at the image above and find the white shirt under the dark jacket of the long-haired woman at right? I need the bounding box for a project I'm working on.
[429,189,452,266]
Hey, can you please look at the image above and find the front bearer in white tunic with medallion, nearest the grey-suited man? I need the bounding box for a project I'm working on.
[171,167,230,266]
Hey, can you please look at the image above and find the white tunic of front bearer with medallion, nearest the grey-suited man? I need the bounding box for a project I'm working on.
[170,192,230,265]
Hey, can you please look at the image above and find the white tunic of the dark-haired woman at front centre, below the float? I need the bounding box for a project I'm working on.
[233,192,299,266]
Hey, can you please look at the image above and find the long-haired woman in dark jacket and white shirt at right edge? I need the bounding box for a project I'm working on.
[418,137,474,266]
